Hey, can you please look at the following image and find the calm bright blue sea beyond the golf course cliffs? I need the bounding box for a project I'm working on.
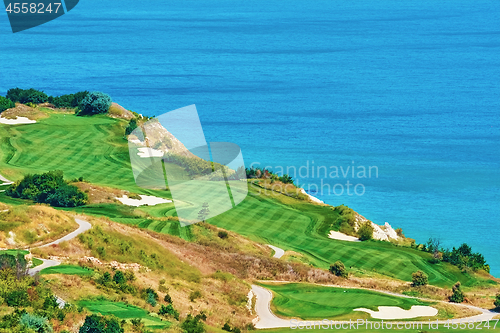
[0,0,500,276]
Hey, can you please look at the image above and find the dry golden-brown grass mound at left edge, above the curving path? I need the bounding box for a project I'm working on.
[0,205,78,248]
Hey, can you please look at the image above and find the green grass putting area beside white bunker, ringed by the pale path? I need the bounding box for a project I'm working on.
[263,283,429,320]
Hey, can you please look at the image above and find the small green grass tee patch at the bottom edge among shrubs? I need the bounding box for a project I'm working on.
[78,299,170,329]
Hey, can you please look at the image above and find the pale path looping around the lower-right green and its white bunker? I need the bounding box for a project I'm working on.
[252,281,498,329]
